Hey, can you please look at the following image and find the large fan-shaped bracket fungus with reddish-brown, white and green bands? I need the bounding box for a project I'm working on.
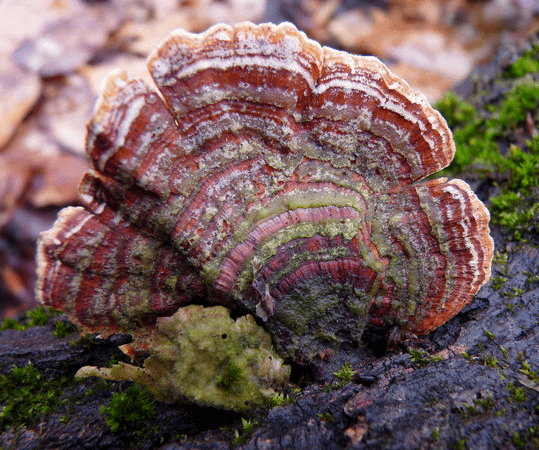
[36,23,493,402]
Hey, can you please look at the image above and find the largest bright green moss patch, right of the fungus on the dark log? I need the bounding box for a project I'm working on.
[436,81,539,240]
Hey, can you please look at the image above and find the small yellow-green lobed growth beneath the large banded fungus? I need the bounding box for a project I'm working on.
[77,305,290,411]
